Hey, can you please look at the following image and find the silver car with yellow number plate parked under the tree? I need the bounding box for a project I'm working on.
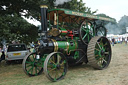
[5,43,29,63]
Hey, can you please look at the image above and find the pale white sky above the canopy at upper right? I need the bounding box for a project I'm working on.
[83,0,128,22]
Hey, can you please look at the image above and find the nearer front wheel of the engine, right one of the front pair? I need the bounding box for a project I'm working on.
[44,52,68,81]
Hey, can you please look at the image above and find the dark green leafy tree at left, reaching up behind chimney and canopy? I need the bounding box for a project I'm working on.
[0,0,95,43]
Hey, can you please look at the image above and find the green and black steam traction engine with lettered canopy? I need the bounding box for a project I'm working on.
[22,5,114,81]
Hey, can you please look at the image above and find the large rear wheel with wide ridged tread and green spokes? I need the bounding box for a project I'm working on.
[87,36,111,69]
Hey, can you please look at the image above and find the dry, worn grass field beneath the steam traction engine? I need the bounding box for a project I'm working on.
[0,44,128,85]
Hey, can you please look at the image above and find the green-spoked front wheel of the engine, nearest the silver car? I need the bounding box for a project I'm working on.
[22,53,44,76]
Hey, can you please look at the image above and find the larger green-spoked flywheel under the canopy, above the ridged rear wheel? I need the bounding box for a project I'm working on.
[79,21,94,44]
